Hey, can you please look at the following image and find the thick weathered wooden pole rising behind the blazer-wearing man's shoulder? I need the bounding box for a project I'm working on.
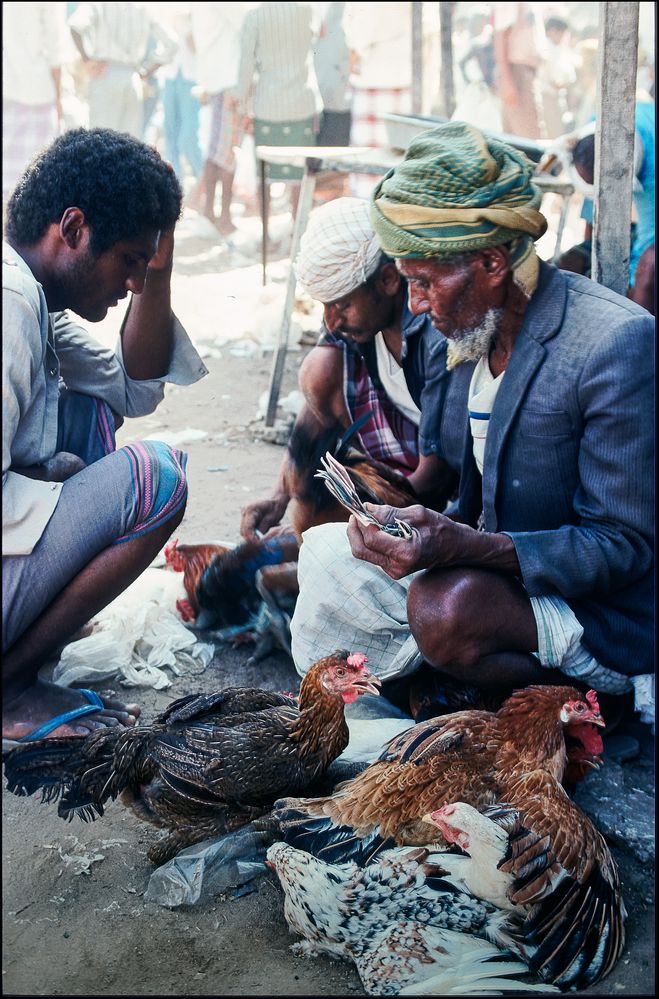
[591,3,639,295]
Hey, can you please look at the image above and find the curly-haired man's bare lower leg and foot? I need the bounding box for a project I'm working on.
[2,508,184,739]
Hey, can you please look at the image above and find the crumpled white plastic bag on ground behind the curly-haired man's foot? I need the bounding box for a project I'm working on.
[53,568,215,690]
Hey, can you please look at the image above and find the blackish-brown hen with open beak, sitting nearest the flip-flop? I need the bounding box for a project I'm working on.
[4,652,380,863]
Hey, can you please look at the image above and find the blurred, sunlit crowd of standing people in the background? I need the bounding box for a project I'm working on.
[3,2,654,223]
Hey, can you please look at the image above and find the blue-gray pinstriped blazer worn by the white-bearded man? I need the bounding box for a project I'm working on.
[422,263,655,676]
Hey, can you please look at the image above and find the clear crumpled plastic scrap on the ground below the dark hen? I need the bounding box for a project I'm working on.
[144,824,267,909]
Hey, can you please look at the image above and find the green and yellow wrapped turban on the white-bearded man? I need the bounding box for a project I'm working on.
[371,121,547,295]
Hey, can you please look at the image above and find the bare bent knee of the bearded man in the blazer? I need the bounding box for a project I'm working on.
[407,569,568,689]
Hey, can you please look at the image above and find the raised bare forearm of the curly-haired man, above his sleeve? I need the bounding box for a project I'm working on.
[121,269,174,381]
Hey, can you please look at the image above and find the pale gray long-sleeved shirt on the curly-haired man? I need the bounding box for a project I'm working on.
[2,242,208,555]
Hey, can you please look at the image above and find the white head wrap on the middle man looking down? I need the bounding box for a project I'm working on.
[293,198,382,304]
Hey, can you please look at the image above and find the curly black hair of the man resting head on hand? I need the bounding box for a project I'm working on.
[5,128,183,256]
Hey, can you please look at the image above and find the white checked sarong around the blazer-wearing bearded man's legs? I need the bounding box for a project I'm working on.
[291,524,634,694]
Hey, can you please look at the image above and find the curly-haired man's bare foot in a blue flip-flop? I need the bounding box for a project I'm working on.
[2,680,140,739]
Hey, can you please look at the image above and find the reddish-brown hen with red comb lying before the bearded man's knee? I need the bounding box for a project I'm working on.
[268,685,604,845]
